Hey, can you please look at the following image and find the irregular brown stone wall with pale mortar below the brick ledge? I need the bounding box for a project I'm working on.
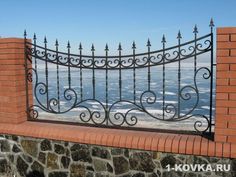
[0,135,236,177]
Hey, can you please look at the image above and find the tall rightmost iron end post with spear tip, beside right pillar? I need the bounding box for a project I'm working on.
[209,19,214,133]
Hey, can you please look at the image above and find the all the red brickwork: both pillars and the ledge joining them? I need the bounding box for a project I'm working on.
[0,32,236,158]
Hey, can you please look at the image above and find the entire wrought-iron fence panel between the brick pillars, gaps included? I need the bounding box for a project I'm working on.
[24,20,214,133]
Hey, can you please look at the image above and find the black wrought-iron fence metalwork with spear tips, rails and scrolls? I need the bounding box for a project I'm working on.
[24,20,214,134]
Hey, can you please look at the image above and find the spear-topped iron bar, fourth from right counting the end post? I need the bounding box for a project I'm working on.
[161,35,166,120]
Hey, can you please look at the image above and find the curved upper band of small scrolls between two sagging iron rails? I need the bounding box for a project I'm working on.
[25,33,213,70]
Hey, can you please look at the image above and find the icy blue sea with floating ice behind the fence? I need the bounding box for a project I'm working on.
[33,60,215,131]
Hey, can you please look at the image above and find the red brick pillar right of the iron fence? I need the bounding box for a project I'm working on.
[215,27,236,143]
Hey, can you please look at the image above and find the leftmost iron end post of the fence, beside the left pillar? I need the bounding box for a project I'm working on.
[24,31,29,119]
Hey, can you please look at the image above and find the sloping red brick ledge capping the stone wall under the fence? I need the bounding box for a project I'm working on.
[0,121,236,158]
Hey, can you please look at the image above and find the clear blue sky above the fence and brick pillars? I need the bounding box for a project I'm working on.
[0,0,236,53]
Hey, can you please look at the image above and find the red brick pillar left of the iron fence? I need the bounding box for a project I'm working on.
[0,38,27,124]
